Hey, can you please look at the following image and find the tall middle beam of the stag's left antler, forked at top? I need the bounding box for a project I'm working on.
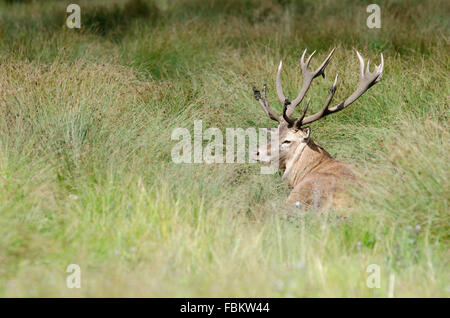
[286,48,336,116]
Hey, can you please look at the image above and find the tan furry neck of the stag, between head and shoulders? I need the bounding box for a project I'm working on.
[283,139,333,187]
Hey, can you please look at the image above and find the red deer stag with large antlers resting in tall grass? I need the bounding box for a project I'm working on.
[253,49,384,209]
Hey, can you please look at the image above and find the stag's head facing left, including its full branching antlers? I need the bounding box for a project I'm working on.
[253,48,384,172]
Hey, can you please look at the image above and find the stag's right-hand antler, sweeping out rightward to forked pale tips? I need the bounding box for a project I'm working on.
[301,51,384,125]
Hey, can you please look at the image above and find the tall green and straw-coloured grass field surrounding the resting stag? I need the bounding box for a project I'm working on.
[0,0,450,297]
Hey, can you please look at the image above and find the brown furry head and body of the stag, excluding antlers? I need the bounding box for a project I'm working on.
[256,123,357,209]
